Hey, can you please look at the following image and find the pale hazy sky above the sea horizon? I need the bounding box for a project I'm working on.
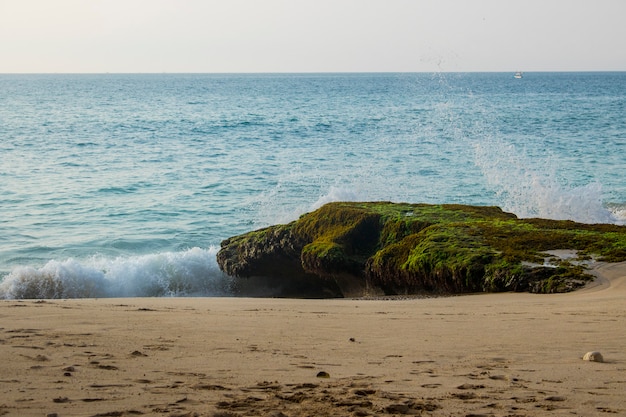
[0,0,626,73]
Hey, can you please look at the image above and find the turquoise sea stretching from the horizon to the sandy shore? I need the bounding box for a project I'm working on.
[0,73,626,298]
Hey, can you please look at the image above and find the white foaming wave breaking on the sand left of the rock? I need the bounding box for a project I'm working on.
[0,247,231,299]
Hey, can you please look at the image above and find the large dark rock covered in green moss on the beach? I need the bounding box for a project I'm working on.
[217,202,626,296]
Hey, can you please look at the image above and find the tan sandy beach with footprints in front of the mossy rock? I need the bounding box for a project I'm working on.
[0,263,626,417]
